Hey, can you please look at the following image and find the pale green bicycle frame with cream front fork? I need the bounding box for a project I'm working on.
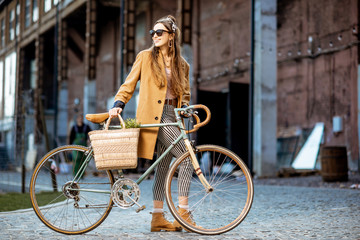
[72,106,213,192]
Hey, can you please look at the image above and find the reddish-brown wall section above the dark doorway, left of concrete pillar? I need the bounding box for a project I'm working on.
[193,0,250,91]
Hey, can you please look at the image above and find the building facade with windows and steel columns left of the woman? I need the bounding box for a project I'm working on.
[0,0,192,171]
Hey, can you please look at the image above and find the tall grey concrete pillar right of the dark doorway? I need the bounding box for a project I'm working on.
[253,0,277,177]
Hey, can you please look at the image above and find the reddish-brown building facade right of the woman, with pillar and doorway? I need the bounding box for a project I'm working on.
[194,0,359,172]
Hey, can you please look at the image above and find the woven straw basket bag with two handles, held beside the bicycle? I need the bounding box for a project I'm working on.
[89,115,140,170]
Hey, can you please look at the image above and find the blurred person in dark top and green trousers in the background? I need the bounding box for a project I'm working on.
[69,114,91,176]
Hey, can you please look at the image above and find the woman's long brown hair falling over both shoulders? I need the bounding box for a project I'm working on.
[150,15,185,96]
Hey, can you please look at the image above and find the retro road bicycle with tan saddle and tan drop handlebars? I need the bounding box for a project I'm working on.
[30,105,254,235]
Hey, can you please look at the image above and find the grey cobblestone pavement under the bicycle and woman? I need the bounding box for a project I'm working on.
[0,177,360,240]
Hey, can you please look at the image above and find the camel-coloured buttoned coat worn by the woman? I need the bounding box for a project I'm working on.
[115,49,190,159]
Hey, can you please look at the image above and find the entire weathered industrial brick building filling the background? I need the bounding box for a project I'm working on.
[0,0,359,175]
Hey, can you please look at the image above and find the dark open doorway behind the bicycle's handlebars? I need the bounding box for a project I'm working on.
[197,83,249,166]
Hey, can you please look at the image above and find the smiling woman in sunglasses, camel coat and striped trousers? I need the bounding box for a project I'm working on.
[109,15,195,231]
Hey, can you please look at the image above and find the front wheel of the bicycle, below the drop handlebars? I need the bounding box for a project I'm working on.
[165,145,254,235]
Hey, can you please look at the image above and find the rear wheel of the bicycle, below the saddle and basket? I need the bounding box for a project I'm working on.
[30,145,114,234]
